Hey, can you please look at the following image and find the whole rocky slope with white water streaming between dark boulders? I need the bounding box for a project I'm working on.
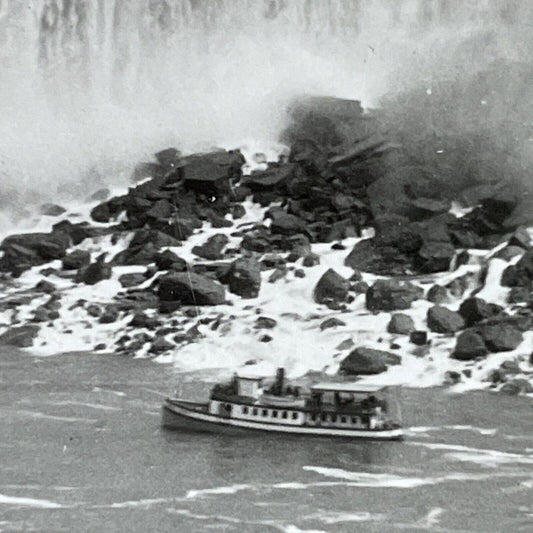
[0,94,533,393]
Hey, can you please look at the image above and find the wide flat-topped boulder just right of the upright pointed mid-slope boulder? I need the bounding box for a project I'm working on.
[366,279,424,311]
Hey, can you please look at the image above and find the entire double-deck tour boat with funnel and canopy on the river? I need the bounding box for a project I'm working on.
[163,369,402,440]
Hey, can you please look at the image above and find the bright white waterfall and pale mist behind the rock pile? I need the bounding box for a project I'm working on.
[0,0,532,216]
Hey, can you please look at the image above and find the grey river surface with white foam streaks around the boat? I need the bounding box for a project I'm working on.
[0,349,533,533]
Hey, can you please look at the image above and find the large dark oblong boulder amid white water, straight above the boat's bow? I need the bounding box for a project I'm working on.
[158,272,226,305]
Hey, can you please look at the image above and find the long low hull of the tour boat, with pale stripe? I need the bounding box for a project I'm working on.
[163,400,403,440]
